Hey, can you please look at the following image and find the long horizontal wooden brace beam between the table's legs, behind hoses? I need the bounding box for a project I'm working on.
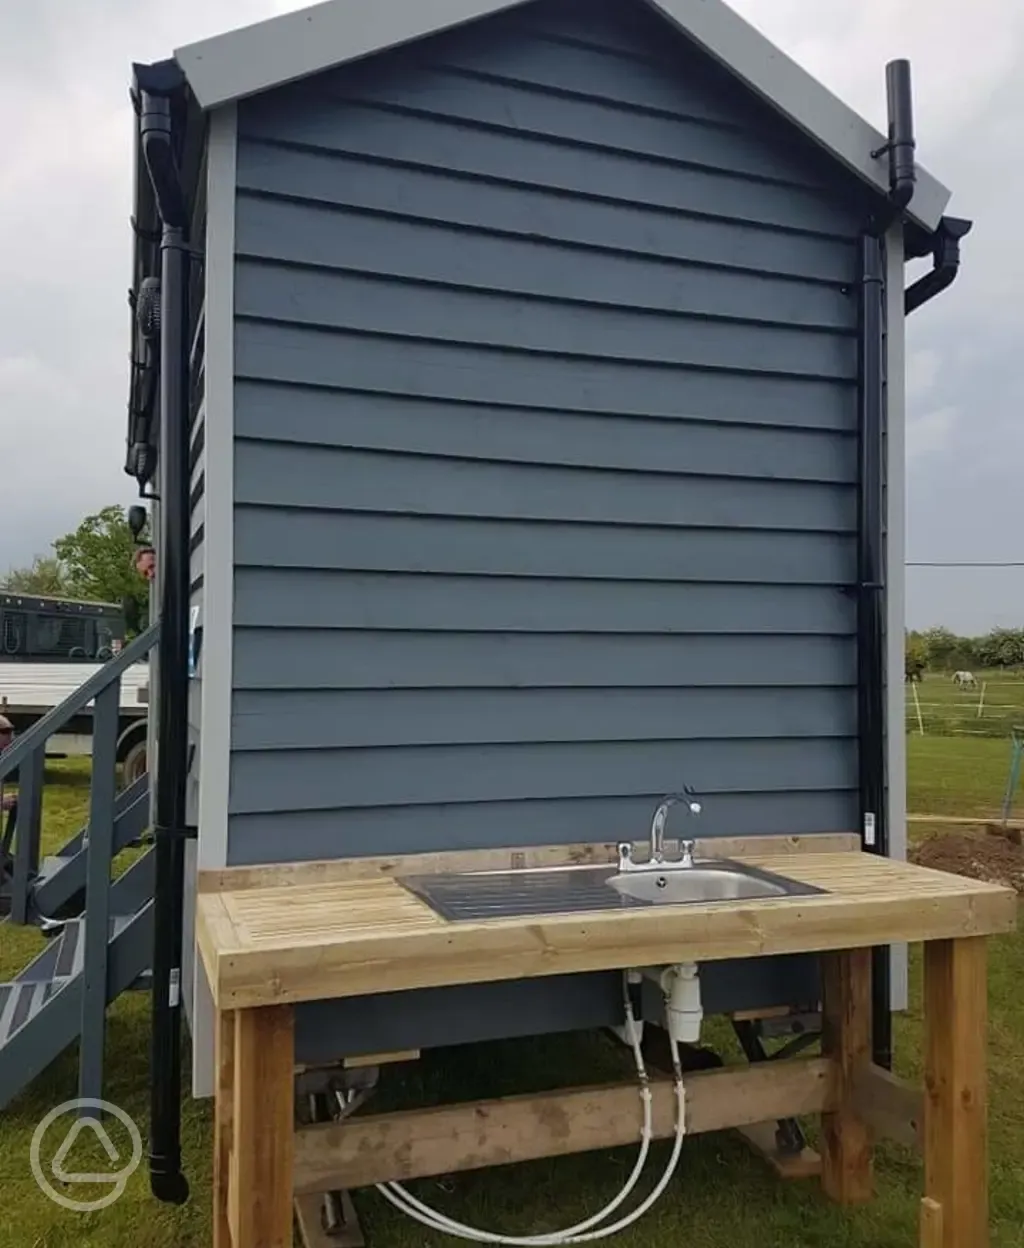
[291,1057,836,1193]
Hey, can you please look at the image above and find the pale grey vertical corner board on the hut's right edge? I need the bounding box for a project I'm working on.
[884,226,909,1010]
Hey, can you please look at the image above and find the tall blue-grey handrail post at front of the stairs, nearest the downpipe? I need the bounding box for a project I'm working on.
[79,678,121,1117]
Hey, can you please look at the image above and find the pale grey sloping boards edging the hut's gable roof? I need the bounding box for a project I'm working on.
[175,0,950,231]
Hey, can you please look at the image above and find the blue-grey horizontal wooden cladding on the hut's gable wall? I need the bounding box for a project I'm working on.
[219,0,864,1047]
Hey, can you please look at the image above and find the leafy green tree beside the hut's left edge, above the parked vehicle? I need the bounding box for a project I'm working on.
[54,505,148,634]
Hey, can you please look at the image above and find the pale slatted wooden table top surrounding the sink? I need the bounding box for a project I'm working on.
[196,837,1018,1010]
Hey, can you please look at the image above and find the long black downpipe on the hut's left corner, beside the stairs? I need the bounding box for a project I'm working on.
[141,80,190,1204]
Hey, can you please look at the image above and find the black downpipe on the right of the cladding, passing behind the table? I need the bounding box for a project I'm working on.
[857,235,888,1070]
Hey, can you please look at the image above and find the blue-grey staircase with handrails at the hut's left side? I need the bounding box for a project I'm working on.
[0,625,158,1109]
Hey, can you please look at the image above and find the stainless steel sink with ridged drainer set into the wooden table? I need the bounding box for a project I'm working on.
[397,859,823,922]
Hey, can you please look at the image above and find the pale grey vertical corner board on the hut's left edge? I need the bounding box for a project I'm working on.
[185,104,237,1097]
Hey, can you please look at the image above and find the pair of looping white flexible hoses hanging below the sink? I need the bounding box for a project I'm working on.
[377,988,686,1248]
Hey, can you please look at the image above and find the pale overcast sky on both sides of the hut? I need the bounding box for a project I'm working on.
[0,0,1024,631]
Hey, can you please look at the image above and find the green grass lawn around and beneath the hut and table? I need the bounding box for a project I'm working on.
[0,738,1024,1248]
